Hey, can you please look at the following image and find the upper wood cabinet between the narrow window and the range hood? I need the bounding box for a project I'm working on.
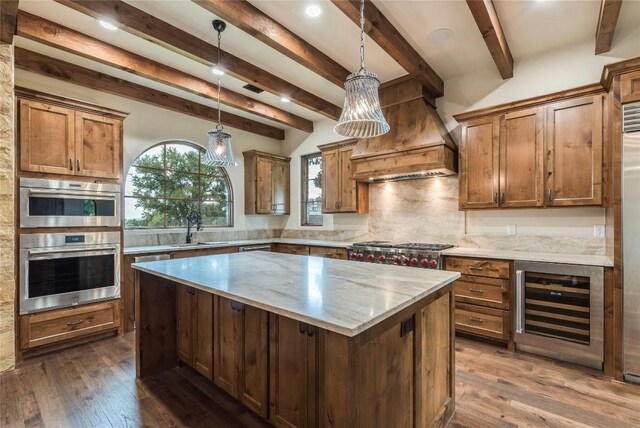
[320,141,369,214]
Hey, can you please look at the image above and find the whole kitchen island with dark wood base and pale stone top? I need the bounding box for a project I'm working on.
[134,252,460,427]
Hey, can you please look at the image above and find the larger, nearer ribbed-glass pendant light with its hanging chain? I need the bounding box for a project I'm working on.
[333,0,390,138]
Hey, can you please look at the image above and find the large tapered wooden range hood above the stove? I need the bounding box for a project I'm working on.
[351,77,458,182]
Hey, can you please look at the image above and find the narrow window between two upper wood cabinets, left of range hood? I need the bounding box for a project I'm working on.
[302,153,322,226]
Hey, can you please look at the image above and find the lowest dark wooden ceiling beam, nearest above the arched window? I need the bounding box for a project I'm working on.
[15,47,284,140]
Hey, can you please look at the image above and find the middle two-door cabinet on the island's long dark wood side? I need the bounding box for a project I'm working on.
[213,296,269,418]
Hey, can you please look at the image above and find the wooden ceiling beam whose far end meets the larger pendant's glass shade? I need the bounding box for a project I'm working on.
[192,0,350,87]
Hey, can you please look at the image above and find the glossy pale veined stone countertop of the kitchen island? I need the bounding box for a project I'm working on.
[133,252,460,337]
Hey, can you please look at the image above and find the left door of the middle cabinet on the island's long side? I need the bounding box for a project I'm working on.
[213,296,243,397]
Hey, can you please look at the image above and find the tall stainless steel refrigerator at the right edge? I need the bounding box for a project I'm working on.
[622,103,640,383]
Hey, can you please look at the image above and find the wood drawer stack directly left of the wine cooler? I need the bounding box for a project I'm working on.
[445,257,513,347]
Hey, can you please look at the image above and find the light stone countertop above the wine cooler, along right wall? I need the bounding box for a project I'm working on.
[443,247,613,267]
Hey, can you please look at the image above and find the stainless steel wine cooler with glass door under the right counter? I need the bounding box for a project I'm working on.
[514,261,604,370]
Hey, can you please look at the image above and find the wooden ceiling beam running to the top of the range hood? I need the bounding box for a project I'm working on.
[331,0,444,98]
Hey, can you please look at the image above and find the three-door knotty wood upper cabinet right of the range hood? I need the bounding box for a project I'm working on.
[460,94,604,209]
